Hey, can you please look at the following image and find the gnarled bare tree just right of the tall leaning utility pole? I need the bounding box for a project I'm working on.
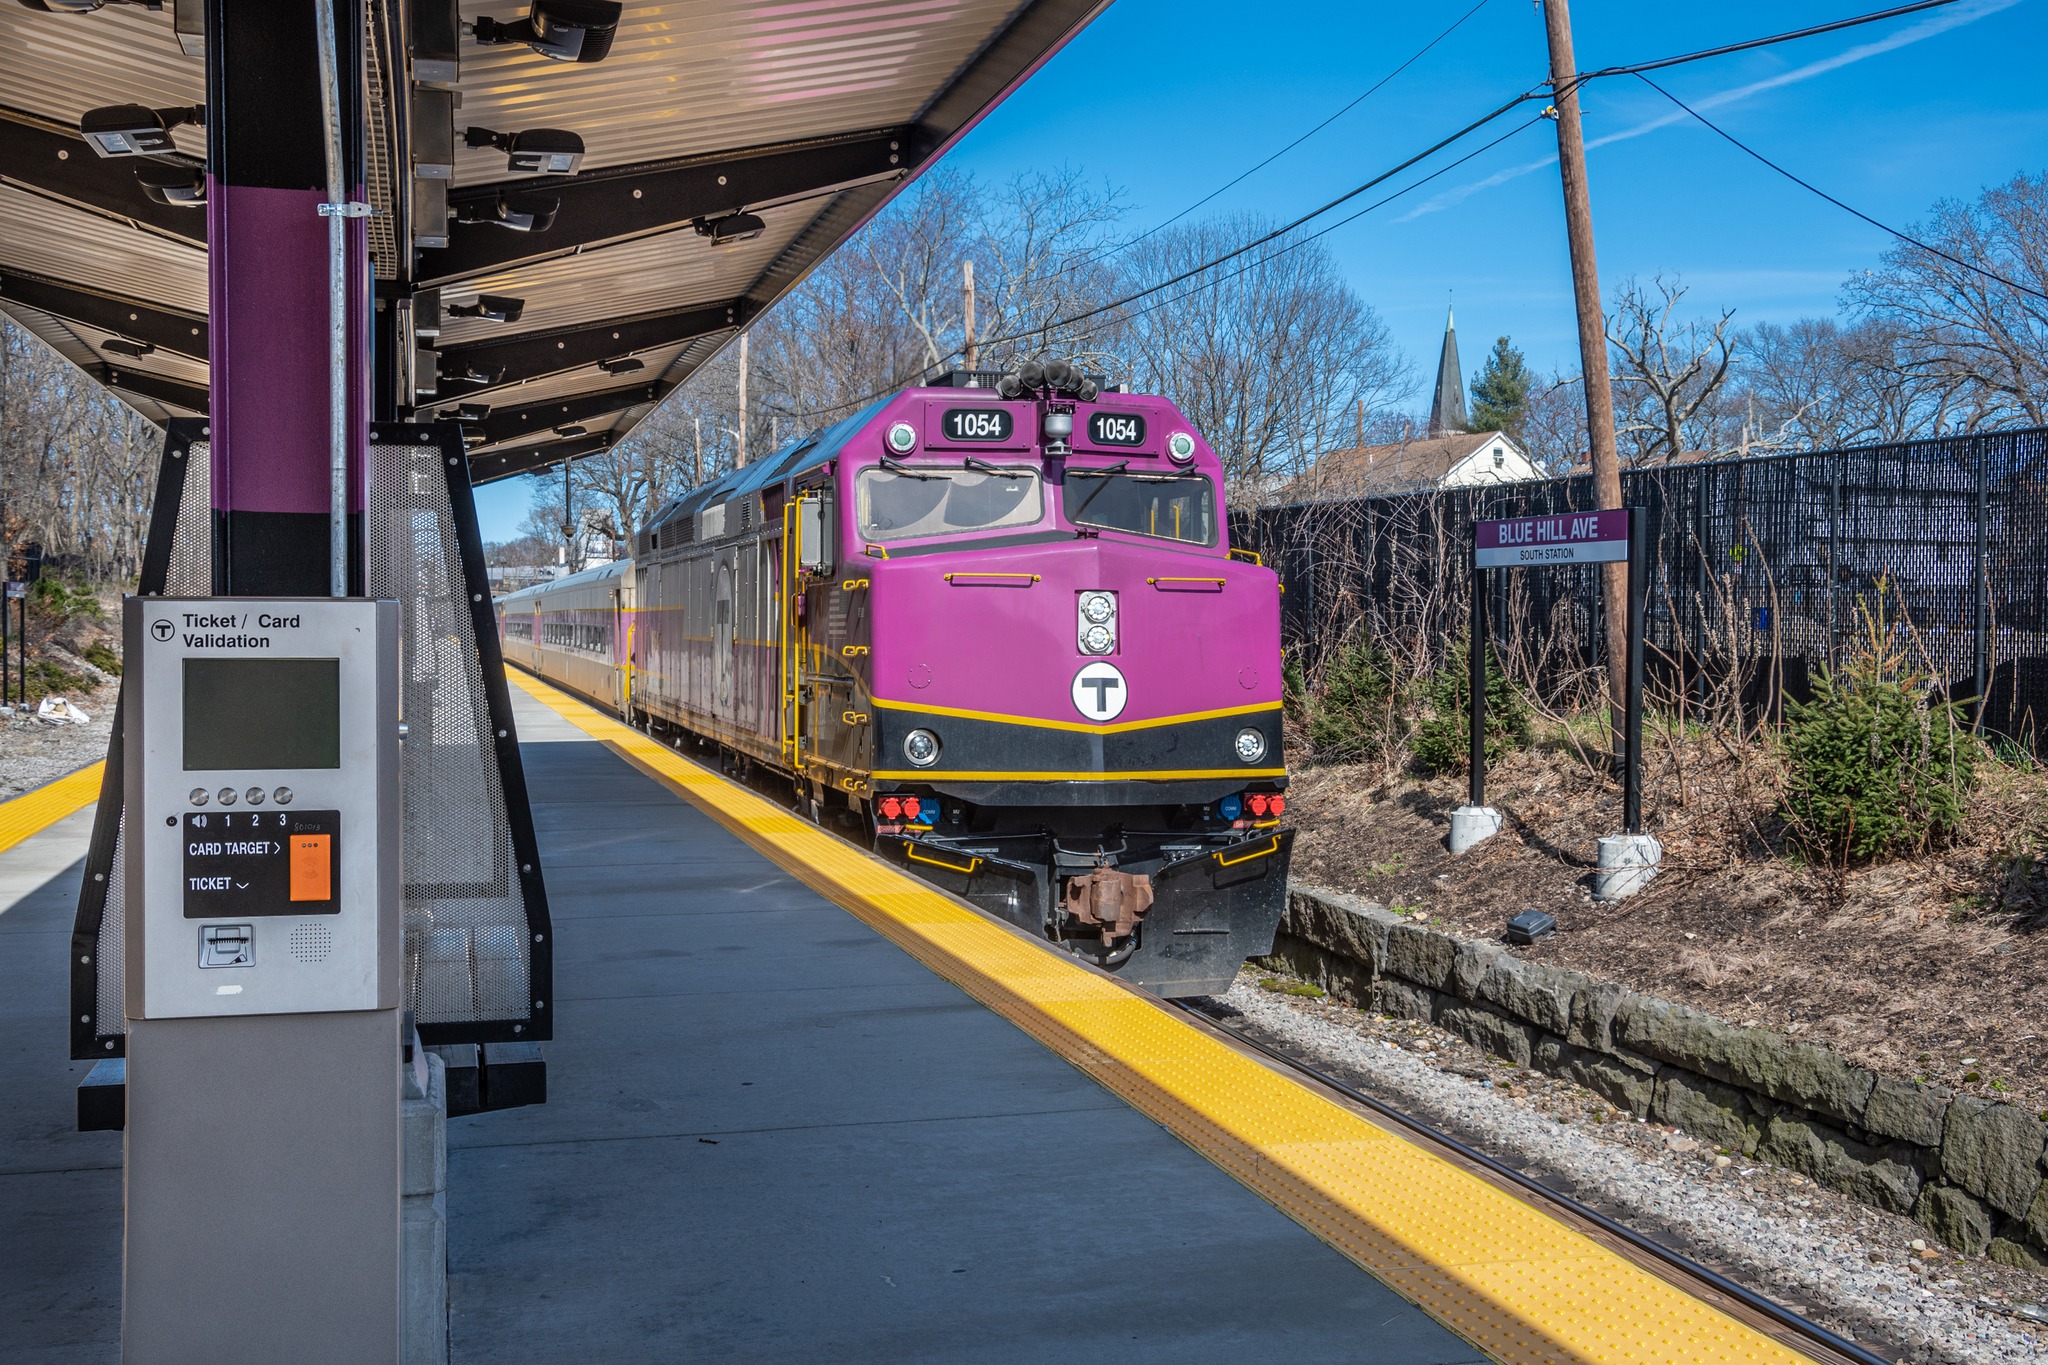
[1608,274,1735,465]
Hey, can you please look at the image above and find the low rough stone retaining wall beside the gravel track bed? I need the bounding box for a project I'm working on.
[1270,882,2048,1269]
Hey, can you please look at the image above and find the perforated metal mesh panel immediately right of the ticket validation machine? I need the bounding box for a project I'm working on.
[365,434,535,1025]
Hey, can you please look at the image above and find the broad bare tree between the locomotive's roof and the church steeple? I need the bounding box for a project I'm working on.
[1124,215,1409,501]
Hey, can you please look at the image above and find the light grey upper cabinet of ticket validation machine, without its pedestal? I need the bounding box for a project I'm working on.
[121,598,403,1019]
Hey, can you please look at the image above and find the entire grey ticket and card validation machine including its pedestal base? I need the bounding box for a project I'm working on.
[123,598,403,1361]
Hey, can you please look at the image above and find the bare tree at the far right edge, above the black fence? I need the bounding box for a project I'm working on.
[1845,174,2048,430]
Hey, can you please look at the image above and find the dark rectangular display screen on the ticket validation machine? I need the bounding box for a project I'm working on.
[184,657,342,772]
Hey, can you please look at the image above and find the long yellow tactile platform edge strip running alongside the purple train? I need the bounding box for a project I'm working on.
[508,673,1806,1365]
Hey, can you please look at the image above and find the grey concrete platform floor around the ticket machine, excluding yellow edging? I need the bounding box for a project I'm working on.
[0,692,1485,1365]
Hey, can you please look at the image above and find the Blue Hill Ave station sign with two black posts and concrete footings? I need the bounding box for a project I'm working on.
[1450,508,1661,900]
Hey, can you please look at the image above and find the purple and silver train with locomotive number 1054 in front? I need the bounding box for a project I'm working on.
[496,358,1294,997]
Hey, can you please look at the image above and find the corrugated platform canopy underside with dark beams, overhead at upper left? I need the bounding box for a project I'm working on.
[0,0,1106,481]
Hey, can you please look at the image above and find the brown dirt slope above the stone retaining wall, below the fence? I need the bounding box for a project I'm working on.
[1288,735,2048,1109]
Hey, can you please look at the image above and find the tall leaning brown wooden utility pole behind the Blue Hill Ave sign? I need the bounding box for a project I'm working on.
[1542,0,1628,761]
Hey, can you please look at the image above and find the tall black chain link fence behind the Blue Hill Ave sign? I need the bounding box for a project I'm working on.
[1233,428,2048,751]
